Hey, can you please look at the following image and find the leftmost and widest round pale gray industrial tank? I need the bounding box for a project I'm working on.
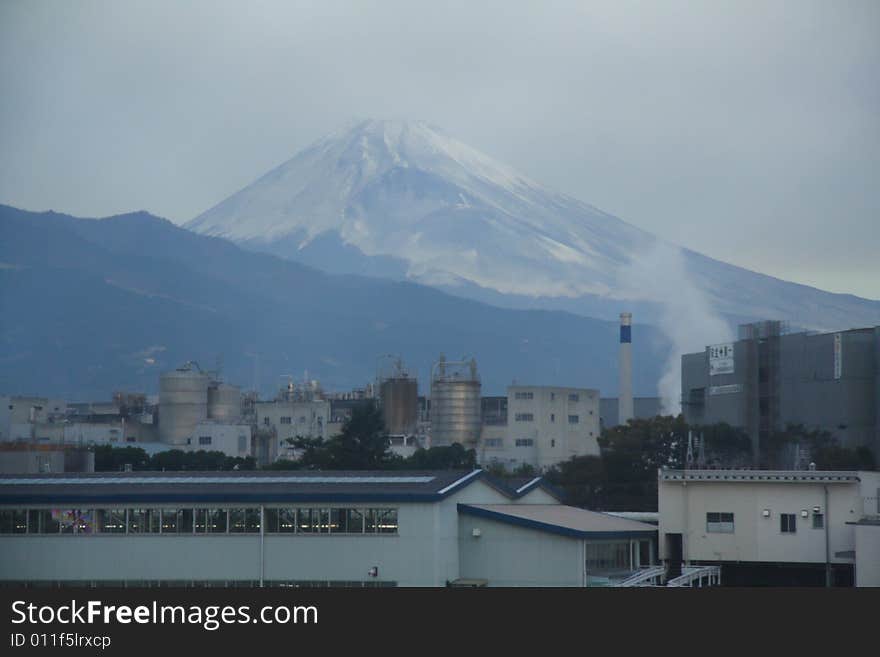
[159,366,210,445]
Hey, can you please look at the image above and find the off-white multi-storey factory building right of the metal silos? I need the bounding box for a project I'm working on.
[477,386,600,470]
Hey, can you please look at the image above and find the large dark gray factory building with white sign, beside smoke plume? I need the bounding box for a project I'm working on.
[681,321,880,456]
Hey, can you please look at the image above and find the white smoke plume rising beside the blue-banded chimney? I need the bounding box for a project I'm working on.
[619,240,734,415]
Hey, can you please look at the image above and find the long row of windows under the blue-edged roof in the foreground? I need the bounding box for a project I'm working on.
[0,508,398,534]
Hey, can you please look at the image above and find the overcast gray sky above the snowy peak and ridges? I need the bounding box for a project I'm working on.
[0,0,880,299]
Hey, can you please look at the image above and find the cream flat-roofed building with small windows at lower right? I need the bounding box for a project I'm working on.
[658,470,880,586]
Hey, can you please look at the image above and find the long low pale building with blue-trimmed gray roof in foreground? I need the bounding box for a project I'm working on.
[0,470,656,587]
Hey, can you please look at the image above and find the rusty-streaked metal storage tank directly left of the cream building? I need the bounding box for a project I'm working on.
[431,356,481,447]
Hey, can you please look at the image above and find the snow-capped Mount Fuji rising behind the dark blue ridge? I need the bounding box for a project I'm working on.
[186,120,880,334]
